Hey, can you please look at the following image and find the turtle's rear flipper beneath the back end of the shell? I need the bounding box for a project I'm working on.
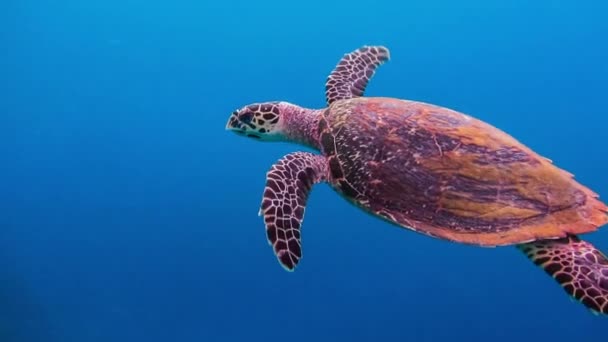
[518,235,608,314]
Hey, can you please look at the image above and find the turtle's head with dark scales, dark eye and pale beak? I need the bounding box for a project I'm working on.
[226,102,293,141]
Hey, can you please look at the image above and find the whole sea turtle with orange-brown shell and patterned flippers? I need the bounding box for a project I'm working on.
[226,46,608,314]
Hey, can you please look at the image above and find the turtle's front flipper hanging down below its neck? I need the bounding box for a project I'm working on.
[260,152,327,271]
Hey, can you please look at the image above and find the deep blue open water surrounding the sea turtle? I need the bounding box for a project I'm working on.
[0,0,608,342]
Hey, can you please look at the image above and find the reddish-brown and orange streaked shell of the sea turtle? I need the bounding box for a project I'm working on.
[319,97,608,246]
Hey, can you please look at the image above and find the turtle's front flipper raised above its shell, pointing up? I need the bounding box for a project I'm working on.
[325,46,390,105]
